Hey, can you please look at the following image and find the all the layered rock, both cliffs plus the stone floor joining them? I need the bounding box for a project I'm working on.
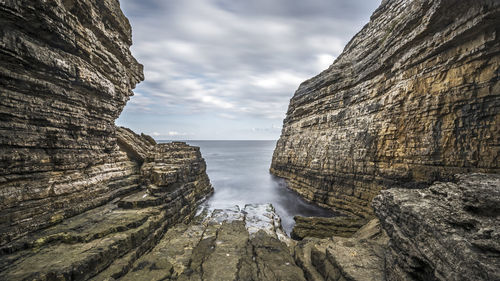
[0,0,500,281]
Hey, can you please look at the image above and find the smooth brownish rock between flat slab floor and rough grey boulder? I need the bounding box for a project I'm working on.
[295,219,388,281]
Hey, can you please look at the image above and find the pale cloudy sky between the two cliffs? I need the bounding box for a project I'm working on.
[116,0,380,140]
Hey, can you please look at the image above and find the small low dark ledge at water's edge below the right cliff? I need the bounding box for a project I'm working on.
[290,216,368,240]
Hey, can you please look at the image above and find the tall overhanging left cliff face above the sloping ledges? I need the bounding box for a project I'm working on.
[0,0,143,245]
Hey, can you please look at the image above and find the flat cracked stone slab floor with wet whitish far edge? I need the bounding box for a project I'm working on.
[114,205,306,281]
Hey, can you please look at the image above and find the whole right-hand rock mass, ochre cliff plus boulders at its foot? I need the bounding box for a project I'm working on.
[271,0,500,281]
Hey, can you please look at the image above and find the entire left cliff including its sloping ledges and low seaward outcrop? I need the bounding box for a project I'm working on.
[0,0,213,274]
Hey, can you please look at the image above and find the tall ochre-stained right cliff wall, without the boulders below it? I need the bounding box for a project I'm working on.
[271,0,500,217]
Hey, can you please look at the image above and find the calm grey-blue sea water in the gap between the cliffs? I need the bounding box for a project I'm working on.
[162,141,334,234]
